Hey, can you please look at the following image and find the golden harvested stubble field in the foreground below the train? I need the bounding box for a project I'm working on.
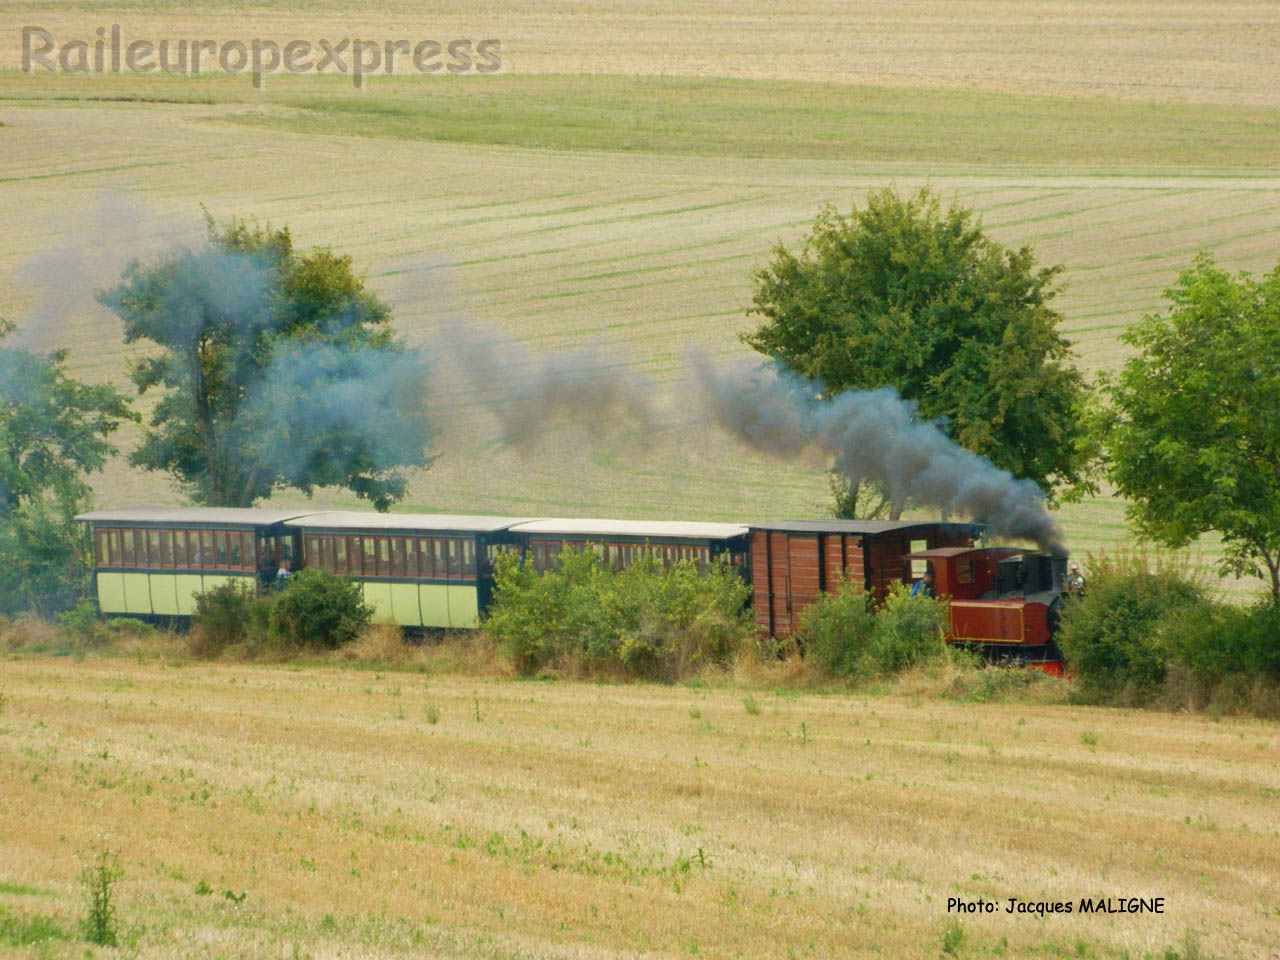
[0,657,1280,957]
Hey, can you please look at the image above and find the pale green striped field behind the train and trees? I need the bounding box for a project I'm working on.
[0,8,1280,593]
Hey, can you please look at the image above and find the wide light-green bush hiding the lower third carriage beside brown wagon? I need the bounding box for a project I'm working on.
[485,549,755,680]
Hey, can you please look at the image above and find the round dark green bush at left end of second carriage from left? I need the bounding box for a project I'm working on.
[269,567,372,650]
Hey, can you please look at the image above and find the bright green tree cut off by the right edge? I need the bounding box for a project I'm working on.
[1097,253,1280,603]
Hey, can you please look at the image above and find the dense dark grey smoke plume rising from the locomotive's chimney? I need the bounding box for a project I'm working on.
[692,357,1062,552]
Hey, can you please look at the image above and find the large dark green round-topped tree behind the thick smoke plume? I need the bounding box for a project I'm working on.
[742,188,1085,516]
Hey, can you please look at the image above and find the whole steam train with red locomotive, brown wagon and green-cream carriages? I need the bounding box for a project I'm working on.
[77,507,1066,673]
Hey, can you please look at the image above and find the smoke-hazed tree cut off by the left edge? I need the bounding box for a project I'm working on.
[0,320,136,616]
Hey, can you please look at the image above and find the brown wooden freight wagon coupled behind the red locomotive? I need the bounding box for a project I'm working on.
[750,520,983,637]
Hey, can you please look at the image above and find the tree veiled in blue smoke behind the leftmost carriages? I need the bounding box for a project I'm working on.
[99,219,430,509]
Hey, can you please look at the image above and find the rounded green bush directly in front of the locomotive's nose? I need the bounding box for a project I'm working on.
[1057,553,1208,701]
